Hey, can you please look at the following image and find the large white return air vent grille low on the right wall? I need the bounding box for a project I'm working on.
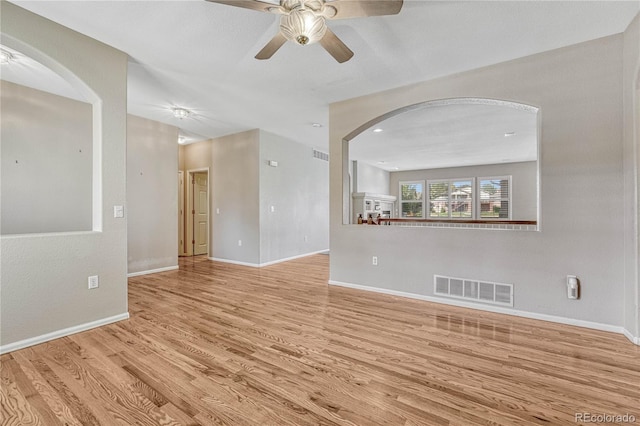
[433,275,513,306]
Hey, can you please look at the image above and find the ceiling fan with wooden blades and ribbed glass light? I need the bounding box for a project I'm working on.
[207,0,403,63]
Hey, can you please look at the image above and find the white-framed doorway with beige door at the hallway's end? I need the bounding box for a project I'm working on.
[186,169,209,256]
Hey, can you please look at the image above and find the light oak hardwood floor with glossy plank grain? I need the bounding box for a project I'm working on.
[0,255,640,426]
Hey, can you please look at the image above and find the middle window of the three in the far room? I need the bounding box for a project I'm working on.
[428,178,474,219]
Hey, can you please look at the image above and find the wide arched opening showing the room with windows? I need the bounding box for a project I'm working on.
[343,98,540,230]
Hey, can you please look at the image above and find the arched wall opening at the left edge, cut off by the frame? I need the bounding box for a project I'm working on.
[0,34,102,235]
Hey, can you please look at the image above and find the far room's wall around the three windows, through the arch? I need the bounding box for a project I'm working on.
[390,161,538,220]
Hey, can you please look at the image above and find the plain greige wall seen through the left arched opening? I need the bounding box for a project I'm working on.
[0,81,93,235]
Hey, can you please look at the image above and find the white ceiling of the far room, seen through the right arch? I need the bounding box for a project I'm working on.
[349,99,538,171]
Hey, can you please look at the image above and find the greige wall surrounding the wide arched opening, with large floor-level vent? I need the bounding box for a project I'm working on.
[330,35,625,327]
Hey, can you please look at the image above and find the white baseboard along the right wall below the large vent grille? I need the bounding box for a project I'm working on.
[329,280,640,345]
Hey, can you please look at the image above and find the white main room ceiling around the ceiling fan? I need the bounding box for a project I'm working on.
[3,0,640,150]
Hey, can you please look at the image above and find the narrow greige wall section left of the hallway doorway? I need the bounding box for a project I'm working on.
[127,115,178,273]
